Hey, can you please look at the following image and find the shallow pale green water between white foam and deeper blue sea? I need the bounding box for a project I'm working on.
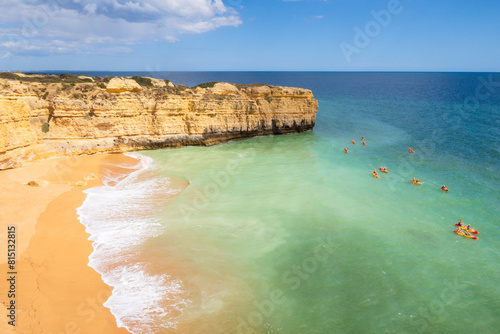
[138,126,499,333]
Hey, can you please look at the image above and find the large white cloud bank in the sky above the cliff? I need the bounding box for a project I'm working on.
[0,0,242,56]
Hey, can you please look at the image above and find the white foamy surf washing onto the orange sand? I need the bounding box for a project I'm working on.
[77,154,189,333]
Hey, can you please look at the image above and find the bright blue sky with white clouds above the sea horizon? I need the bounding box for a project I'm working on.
[0,0,500,72]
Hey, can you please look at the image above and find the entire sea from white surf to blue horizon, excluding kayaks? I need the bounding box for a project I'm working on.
[75,72,500,333]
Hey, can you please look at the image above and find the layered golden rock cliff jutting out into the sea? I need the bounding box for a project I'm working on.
[0,75,318,169]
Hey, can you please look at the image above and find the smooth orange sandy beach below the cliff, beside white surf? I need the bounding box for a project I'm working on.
[0,154,137,333]
